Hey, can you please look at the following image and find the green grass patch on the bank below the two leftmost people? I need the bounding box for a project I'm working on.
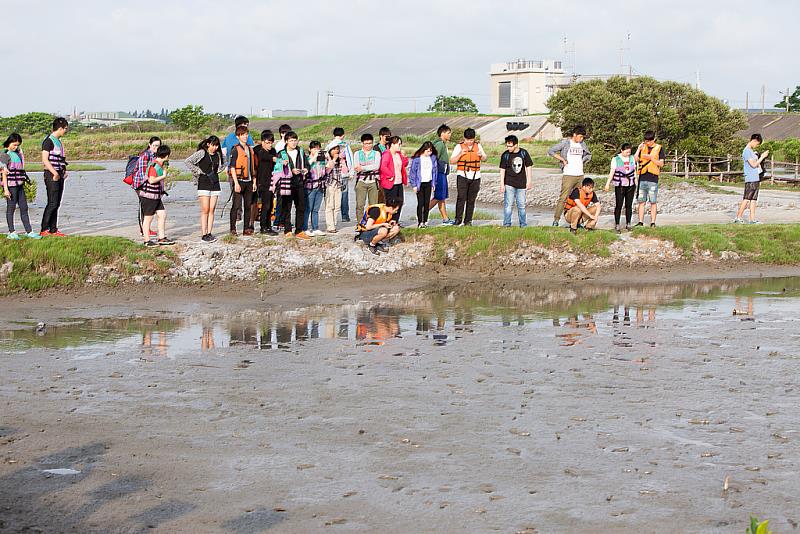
[0,237,175,293]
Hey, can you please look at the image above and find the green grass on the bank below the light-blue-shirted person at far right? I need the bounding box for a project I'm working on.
[633,224,800,265]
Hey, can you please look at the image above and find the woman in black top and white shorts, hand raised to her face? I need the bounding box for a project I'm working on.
[184,135,225,243]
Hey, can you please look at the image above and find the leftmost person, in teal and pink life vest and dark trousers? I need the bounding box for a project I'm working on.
[0,132,42,240]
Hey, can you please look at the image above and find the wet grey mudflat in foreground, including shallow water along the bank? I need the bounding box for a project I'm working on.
[0,278,800,533]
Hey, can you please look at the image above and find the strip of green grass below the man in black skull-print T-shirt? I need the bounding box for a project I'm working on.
[403,226,617,260]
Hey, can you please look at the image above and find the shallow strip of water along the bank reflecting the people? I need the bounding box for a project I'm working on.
[0,278,800,360]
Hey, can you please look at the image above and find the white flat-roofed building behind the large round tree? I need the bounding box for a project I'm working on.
[489,59,573,115]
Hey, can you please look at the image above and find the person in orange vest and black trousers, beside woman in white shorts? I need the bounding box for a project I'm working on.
[228,126,258,235]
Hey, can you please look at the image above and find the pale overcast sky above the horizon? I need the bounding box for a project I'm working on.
[0,0,800,116]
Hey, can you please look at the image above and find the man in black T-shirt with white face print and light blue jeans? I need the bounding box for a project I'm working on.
[500,135,533,228]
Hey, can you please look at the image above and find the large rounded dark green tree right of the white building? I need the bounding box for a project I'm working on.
[547,76,747,172]
